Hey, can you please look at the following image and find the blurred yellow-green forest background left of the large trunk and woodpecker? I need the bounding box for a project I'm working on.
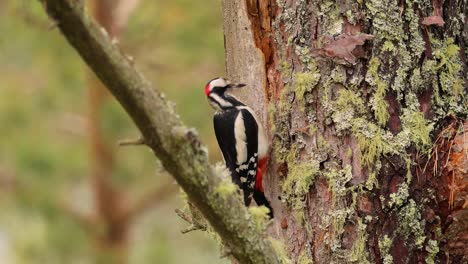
[0,0,227,264]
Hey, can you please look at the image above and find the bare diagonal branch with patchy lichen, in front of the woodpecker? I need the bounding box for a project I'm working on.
[39,0,280,264]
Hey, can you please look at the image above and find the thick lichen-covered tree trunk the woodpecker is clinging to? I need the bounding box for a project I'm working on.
[223,0,468,263]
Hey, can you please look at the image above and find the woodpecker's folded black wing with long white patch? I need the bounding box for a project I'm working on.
[214,108,258,206]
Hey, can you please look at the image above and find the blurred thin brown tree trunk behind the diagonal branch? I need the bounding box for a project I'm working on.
[87,0,130,264]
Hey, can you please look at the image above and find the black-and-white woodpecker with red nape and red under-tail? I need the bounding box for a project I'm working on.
[205,78,273,218]
